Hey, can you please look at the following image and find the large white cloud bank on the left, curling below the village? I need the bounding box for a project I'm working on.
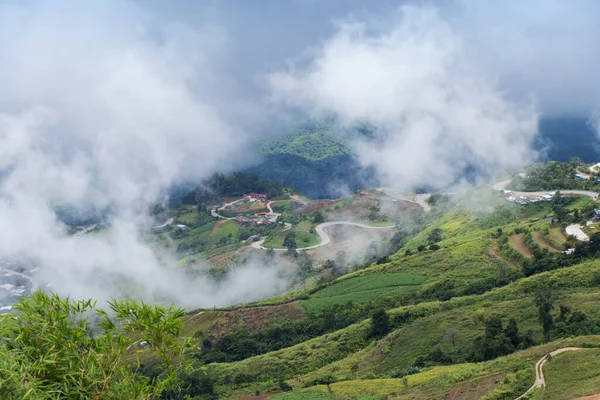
[0,1,284,306]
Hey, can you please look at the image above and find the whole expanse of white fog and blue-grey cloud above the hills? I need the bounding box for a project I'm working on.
[0,0,600,307]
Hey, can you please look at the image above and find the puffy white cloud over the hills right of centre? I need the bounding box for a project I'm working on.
[270,7,537,187]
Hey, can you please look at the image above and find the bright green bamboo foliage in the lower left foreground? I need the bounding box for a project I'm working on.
[0,292,191,400]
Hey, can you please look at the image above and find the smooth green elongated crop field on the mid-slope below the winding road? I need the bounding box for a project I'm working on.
[302,273,427,313]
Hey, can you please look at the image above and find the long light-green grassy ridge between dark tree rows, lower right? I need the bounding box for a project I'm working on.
[209,261,600,392]
